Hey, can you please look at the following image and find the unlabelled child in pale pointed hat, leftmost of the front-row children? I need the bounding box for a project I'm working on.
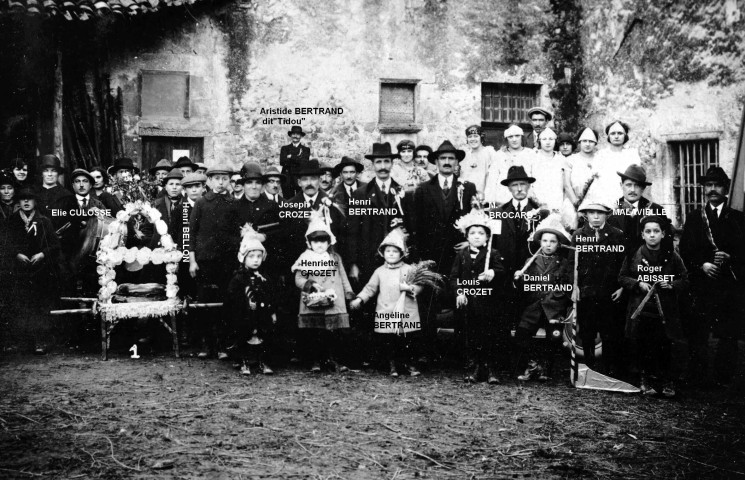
[225,224,277,375]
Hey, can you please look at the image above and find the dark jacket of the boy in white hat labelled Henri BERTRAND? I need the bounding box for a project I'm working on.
[572,222,626,301]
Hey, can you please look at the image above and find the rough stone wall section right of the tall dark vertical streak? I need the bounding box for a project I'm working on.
[583,0,745,222]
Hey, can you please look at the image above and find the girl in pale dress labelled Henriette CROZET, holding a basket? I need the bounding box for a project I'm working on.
[291,211,354,373]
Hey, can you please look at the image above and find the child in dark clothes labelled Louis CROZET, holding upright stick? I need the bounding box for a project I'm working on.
[450,211,508,385]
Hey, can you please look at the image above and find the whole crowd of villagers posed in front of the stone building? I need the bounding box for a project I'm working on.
[0,108,745,396]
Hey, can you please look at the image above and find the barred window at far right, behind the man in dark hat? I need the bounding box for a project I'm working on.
[668,139,719,223]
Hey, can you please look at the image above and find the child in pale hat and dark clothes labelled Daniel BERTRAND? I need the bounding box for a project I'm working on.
[513,214,574,381]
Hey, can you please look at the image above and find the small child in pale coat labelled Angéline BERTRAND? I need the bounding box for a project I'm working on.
[350,227,422,377]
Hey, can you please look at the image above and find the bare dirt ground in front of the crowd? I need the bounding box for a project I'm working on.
[0,353,745,479]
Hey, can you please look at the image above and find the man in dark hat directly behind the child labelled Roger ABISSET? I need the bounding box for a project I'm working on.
[608,165,673,258]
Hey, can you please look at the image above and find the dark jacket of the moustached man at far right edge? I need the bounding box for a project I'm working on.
[680,205,745,292]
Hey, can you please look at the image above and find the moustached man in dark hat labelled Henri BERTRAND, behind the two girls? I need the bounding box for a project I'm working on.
[343,142,404,285]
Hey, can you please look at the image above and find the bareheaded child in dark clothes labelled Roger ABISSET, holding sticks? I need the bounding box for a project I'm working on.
[618,215,688,397]
